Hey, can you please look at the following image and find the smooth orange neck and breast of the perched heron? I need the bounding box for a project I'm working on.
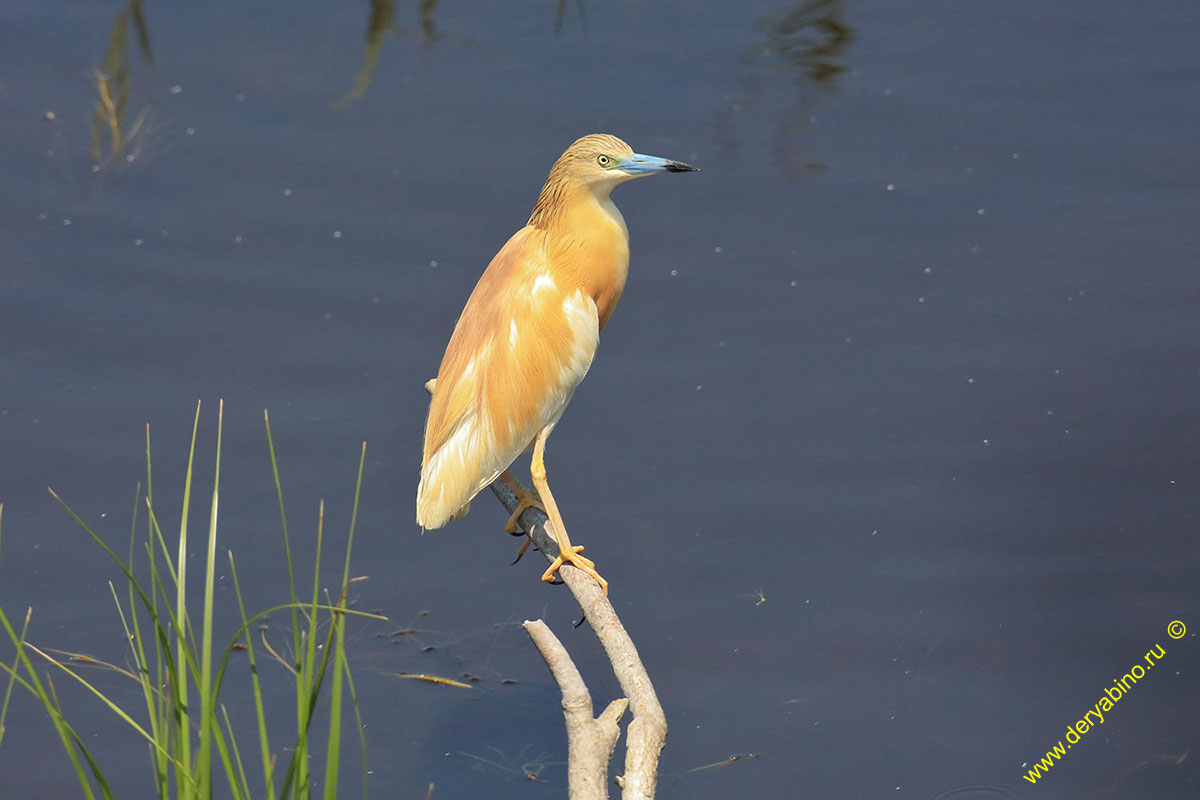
[542,188,629,327]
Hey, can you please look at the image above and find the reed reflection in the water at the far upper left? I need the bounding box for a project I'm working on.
[90,0,154,162]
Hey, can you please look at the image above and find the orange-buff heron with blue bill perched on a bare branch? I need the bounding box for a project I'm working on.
[416,133,697,594]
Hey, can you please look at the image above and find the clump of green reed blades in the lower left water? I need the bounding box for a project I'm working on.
[0,403,385,800]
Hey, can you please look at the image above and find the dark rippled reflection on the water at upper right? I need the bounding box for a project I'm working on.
[713,0,854,178]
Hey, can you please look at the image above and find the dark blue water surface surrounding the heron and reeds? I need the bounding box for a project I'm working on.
[0,0,1200,800]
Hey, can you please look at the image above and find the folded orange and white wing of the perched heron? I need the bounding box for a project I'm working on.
[416,228,599,529]
